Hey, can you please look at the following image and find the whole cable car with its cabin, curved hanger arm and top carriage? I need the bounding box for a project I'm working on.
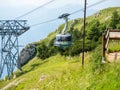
[54,14,72,47]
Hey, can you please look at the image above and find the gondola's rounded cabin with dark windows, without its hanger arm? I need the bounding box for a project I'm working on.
[54,33,72,47]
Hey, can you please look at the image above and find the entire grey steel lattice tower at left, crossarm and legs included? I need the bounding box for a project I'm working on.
[0,20,30,79]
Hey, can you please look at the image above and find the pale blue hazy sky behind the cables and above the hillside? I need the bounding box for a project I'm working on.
[0,0,120,79]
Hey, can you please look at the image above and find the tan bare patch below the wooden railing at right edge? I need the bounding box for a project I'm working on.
[106,52,120,62]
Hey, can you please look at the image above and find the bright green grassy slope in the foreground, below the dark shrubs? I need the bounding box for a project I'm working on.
[0,47,120,90]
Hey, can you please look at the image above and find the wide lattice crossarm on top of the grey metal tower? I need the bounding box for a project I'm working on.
[0,20,30,36]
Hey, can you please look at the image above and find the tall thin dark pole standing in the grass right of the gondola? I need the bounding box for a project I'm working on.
[82,0,87,67]
